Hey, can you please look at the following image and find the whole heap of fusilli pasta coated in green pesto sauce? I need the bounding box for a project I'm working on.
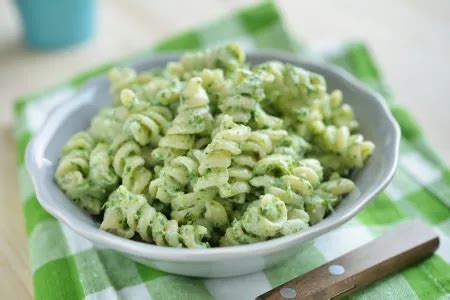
[55,44,375,248]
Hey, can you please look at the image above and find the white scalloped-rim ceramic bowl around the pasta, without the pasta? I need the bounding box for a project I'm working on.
[26,51,400,277]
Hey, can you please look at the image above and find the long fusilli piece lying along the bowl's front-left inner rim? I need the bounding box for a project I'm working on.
[100,186,209,248]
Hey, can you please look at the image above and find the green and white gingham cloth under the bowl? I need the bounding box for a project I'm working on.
[15,2,450,300]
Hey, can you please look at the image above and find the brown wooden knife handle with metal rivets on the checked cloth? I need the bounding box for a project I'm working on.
[256,220,439,300]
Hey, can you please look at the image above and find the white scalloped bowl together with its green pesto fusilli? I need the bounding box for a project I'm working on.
[26,44,400,277]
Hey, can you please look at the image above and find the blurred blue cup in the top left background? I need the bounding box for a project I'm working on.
[16,0,95,49]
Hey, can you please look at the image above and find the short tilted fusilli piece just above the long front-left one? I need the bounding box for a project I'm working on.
[109,135,152,194]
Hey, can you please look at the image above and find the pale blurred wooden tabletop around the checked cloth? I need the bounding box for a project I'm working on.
[0,0,450,299]
